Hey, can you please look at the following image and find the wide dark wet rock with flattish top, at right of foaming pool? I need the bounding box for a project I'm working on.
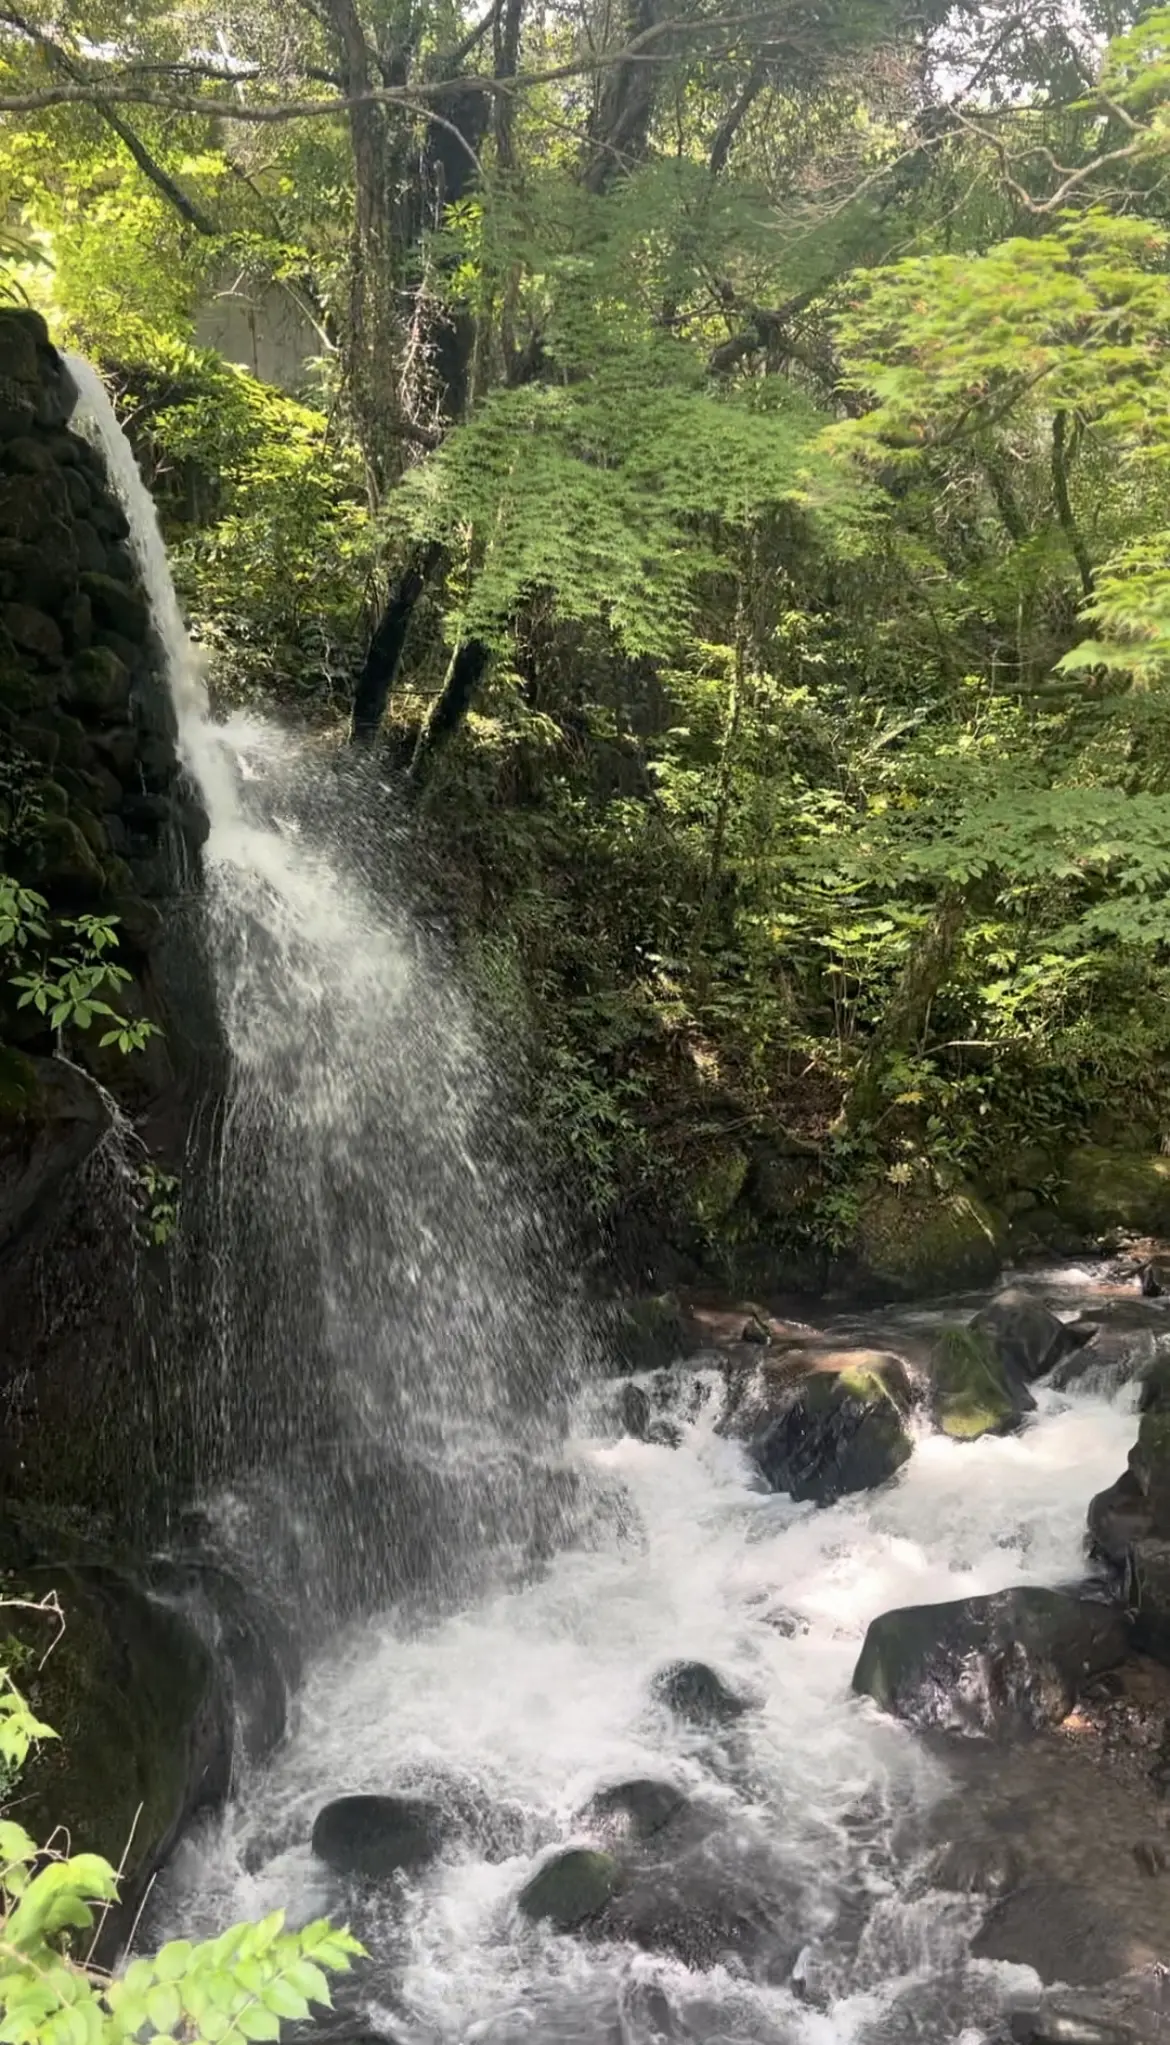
[853,1587,1129,1732]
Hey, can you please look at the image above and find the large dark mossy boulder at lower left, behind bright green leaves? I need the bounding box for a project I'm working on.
[4,1562,231,1902]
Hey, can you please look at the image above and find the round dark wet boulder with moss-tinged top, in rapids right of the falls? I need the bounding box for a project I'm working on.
[720,1339,912,1505]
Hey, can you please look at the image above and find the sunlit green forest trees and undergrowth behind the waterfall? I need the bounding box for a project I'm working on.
[0,0,1170,1258]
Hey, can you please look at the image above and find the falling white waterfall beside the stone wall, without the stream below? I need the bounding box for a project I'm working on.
[70,360,583,1609]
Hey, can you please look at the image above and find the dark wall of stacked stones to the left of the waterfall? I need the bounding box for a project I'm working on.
[0,309,205,1521]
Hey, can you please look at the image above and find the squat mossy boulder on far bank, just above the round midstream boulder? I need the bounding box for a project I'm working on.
[853,1186,1006,1299]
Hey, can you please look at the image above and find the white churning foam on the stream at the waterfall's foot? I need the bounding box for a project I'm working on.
[157,1391,1133,2045]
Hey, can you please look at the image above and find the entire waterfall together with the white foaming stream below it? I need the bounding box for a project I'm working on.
[74,364,1161,2045]
